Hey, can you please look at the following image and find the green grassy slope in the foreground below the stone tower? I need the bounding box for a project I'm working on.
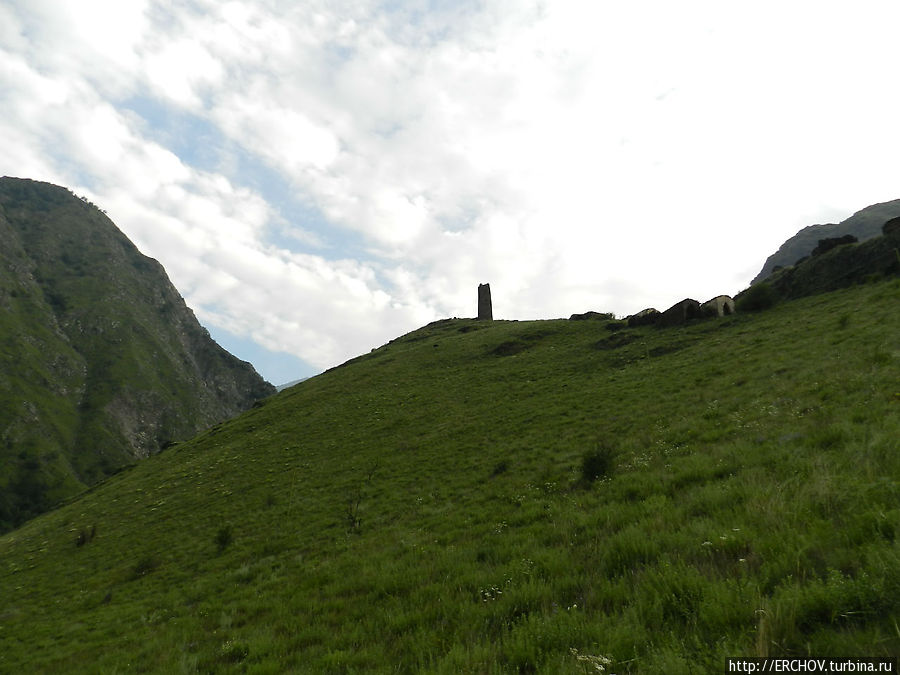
[0,278,900,674]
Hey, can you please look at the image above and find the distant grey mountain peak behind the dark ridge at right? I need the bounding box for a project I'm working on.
[751,199,900,284]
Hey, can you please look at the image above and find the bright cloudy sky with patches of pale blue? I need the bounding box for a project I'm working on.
[0,0,900,384]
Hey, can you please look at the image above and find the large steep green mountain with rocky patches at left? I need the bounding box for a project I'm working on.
[0,178,274,530]
